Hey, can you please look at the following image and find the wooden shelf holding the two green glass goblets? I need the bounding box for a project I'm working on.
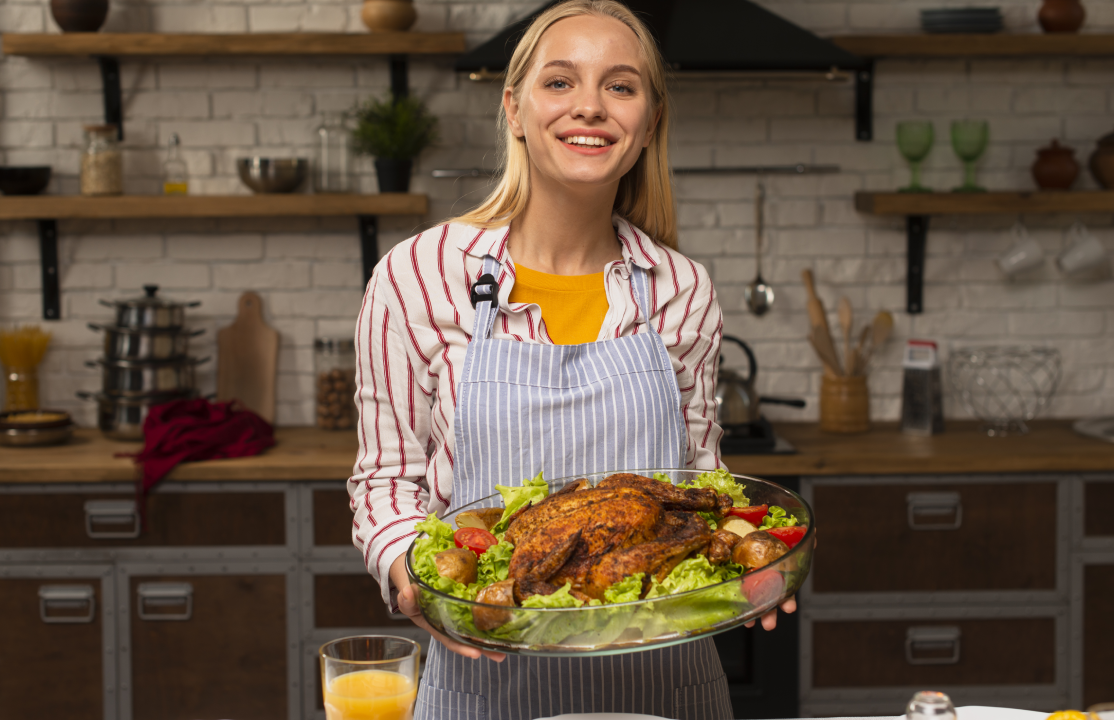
[854,191,1114,215]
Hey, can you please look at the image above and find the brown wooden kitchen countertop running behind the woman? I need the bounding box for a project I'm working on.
[0,420,1114,483]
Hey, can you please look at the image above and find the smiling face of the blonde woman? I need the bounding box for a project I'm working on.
[504,14,656,191]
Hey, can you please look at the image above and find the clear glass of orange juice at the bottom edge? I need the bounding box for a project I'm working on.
[319,635,421,720]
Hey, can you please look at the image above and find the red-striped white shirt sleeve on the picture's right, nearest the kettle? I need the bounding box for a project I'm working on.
[657,255,723,470]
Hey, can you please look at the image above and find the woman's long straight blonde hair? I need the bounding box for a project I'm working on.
[453,0,677,250]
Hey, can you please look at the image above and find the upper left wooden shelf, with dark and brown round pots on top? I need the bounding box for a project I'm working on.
[3,32,465,57]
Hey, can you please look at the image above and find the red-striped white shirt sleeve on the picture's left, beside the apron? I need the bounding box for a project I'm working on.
[348,259,431,610]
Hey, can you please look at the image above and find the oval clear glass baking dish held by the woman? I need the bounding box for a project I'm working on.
[407,469,815,656]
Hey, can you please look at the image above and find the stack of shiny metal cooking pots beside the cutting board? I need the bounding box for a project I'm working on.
[78,285,208,440]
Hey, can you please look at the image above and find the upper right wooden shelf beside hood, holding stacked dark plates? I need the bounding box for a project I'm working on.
[828,35,1114,58]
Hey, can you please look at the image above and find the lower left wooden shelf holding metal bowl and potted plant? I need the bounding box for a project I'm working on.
[0,193,429,220]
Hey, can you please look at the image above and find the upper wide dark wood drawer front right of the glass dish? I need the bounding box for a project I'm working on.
[812,483,1057,593]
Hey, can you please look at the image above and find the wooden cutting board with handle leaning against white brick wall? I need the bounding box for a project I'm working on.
[216,292,279,422]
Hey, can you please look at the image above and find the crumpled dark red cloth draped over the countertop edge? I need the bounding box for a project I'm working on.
[134,398,275,497]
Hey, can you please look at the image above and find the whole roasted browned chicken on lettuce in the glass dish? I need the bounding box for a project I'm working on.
[500,473,737,604]
